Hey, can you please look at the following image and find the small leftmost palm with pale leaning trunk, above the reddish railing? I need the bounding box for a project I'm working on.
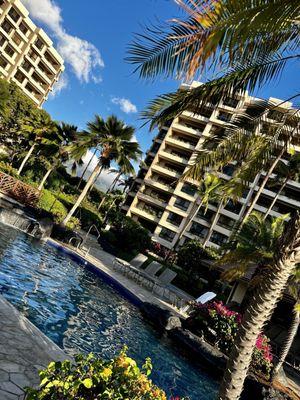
[17,110,57,175]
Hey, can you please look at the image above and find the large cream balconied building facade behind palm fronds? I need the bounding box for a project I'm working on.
[123,82,300,249]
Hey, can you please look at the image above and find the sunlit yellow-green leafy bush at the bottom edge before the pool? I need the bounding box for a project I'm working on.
[26,350,167,400]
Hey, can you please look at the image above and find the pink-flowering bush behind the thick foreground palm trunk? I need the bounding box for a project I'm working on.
[193,301,273,378]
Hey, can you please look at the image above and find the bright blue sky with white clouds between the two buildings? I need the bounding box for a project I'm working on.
[22,0,299,159]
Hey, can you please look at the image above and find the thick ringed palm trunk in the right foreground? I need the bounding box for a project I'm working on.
[218,213,300,400]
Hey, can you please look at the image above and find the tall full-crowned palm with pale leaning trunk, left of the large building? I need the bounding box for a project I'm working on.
[62,115,138,225]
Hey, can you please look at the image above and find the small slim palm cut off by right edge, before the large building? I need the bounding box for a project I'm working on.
[264,154,300,219]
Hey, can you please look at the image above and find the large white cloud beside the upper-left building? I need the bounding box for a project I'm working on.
[23,0,104,83]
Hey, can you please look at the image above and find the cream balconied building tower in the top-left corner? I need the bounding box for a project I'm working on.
[0,0,64,106]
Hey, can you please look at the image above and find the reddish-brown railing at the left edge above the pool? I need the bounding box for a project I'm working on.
[0,172,40,206]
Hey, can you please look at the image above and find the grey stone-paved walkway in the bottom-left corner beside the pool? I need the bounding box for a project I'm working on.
[0,295,68,400]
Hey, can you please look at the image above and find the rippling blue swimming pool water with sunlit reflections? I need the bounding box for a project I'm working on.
[0,224,217,400]
